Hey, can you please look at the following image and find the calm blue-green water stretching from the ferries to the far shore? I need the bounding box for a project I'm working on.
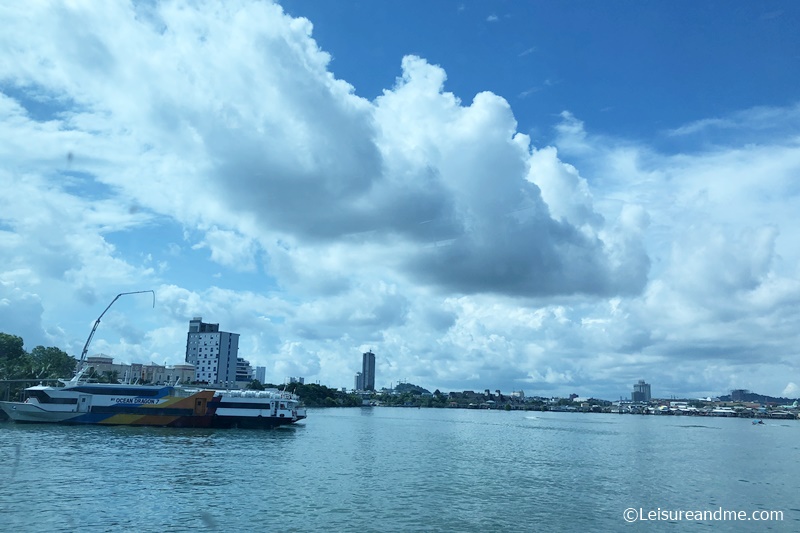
[0,407,800,532]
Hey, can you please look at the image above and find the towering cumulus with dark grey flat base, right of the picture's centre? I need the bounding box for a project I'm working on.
[376,57,648,296]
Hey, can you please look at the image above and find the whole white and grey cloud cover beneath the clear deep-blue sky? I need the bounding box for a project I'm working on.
[0,0,800,397]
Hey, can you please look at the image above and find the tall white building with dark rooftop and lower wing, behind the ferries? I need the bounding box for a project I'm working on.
[186,317,241,385]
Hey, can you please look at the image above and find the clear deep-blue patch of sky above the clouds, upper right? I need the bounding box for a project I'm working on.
[284,1,800,141]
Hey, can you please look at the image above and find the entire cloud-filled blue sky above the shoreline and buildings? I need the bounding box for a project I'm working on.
[0,0,800,400]
